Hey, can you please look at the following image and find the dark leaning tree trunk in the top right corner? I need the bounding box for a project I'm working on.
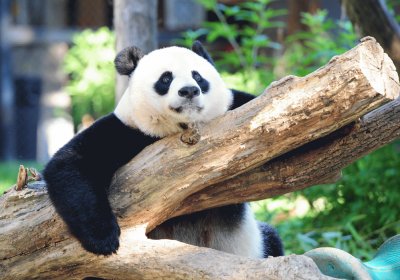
[342,0,400,70]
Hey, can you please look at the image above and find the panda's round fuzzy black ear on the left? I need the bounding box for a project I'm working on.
[114,46,144,76]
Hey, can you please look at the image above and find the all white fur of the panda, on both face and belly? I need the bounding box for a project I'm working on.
[114,47,264,258]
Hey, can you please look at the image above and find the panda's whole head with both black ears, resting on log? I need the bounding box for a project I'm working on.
[115,42,232,137]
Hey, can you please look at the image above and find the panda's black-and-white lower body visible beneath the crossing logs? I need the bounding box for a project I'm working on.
[148,203,283,258]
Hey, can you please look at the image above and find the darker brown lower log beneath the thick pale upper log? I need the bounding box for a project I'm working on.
[173,99,400,216]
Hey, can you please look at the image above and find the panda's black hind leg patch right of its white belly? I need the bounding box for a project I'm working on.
[258,222,284,258]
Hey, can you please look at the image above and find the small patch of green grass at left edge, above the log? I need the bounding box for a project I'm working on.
[0,162,43,195]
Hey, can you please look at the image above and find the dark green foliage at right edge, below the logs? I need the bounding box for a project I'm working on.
[302,143,400,229]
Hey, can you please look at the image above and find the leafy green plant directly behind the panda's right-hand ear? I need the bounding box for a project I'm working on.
[179,0,286,92]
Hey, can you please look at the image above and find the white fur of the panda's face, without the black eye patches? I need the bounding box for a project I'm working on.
[114,47,232,137]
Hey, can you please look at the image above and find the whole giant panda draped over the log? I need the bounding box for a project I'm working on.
[43,42,283,258]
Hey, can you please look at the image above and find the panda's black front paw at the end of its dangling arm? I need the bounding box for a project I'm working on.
[80,218,121,256]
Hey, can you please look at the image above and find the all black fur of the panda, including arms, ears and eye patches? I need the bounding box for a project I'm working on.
[43,42,283,257]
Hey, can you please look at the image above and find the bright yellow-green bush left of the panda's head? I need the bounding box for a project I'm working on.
[64,27,115,127]
